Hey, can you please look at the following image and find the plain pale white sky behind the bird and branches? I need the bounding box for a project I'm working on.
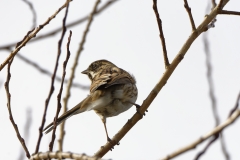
[0,0,240,160]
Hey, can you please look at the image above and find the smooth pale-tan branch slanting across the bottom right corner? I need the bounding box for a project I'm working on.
[162,109,240,160]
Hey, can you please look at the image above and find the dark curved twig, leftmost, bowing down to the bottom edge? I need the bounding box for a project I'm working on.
[5,59,30,158]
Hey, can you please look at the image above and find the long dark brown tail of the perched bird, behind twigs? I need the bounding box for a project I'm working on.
[43,104,84,134]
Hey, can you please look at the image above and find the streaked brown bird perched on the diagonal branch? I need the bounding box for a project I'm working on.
[43,59,139,141]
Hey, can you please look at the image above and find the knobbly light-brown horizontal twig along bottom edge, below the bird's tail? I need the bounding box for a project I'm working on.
[29,152,101,160]
